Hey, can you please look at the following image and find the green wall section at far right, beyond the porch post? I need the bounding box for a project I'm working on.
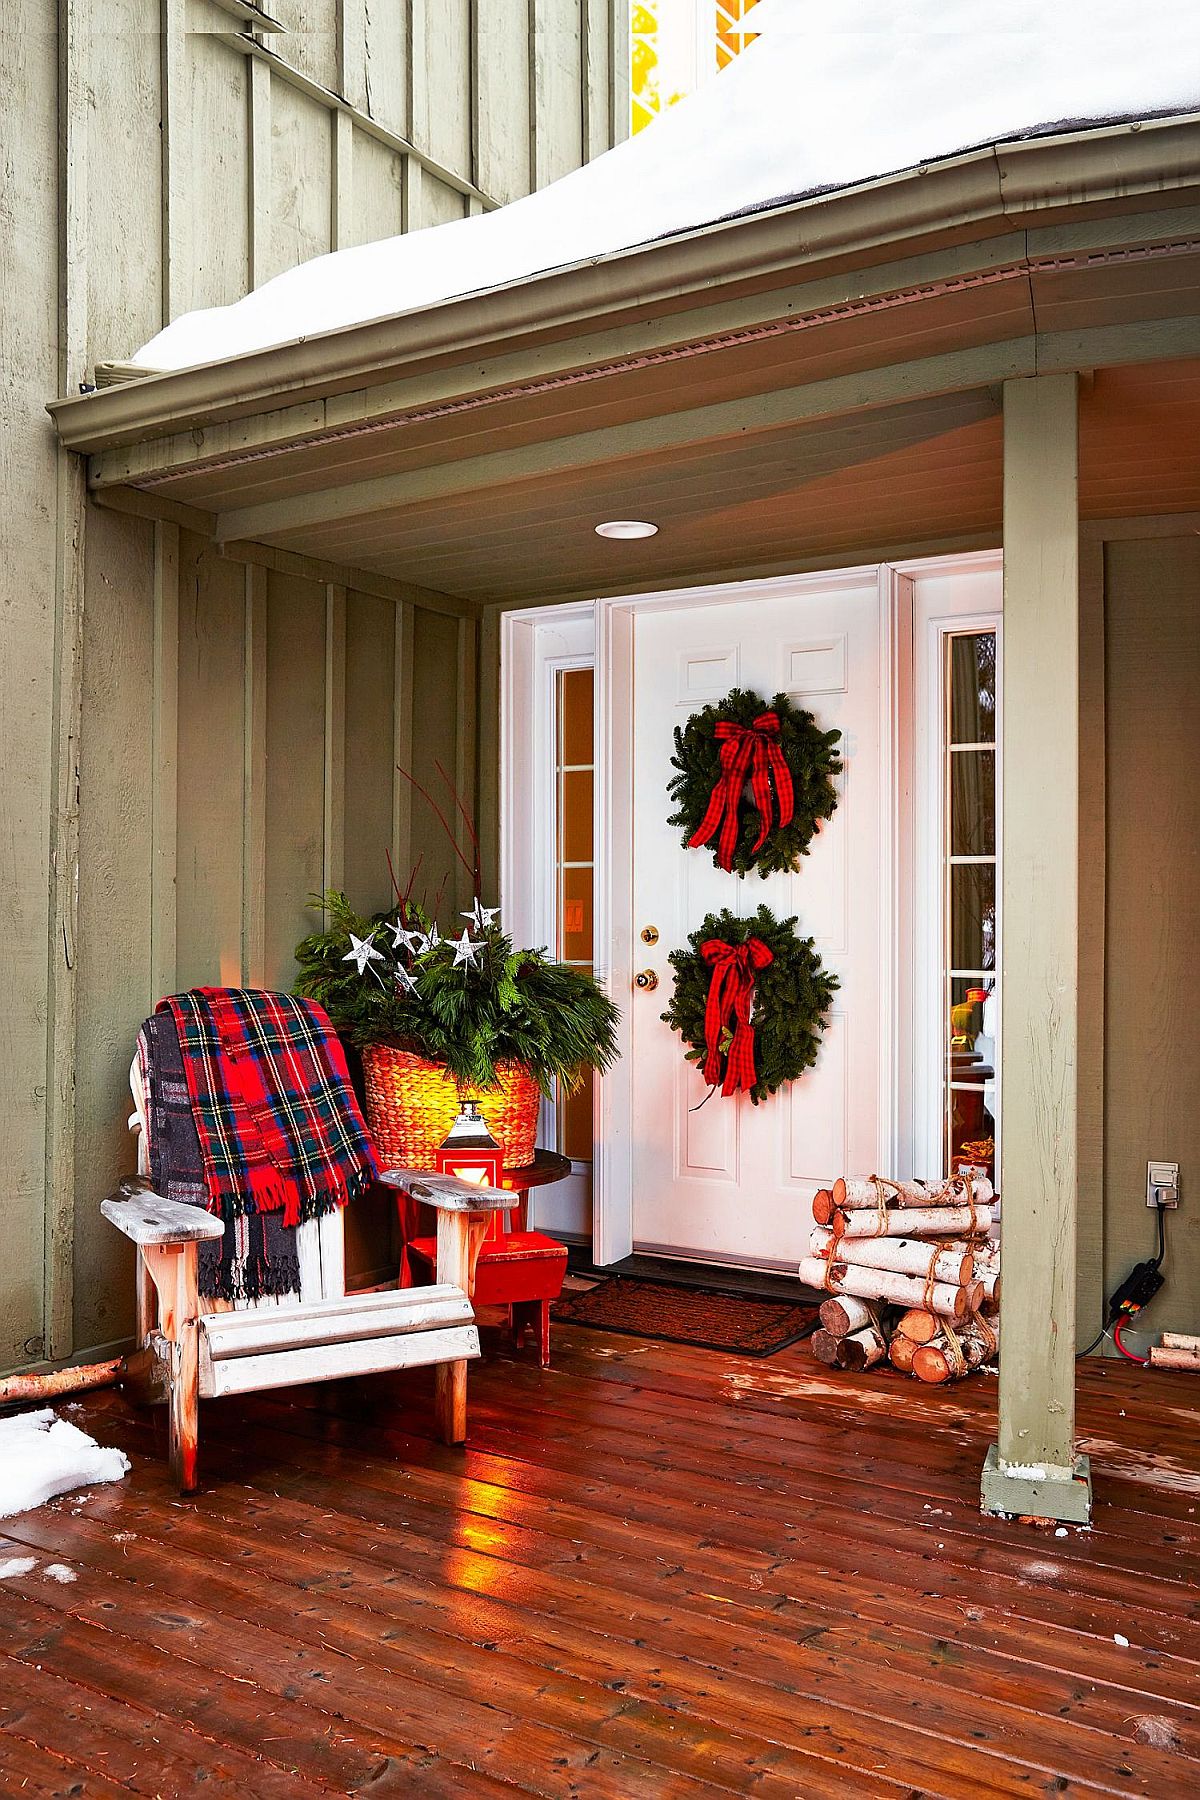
[1105,536,1200,1334]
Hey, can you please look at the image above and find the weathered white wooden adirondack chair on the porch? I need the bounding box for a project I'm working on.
[101,1057,513,1494]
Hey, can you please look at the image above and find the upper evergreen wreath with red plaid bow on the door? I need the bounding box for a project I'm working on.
[667,688,842,880]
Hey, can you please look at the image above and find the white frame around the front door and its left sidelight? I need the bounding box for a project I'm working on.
[500,551,1000,1264]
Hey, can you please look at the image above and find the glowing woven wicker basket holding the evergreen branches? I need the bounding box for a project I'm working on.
[362,1044,542,1168]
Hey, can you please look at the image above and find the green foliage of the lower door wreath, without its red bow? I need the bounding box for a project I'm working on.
[662,905,840,1105]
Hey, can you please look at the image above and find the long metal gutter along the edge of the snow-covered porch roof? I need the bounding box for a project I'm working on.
[49,113,1200,452]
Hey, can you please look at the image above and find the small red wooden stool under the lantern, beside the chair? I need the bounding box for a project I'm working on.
[401,1150,570,1368]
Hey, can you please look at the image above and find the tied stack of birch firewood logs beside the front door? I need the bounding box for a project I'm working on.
[799,1168,1000,1382]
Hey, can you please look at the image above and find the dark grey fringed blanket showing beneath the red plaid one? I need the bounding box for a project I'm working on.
[137,1012,300,1301]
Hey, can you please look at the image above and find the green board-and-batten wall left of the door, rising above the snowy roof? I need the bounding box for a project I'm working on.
[0,0,628,1368]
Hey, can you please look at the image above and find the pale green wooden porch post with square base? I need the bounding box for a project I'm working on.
[982,374,1092,1521]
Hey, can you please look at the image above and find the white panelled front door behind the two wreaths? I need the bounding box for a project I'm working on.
[610,569,891,1269]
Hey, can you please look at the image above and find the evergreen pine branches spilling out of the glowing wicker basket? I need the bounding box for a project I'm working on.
[295,891,619,1094]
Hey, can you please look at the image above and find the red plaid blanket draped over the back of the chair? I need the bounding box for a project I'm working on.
[157,988,378,1226]
